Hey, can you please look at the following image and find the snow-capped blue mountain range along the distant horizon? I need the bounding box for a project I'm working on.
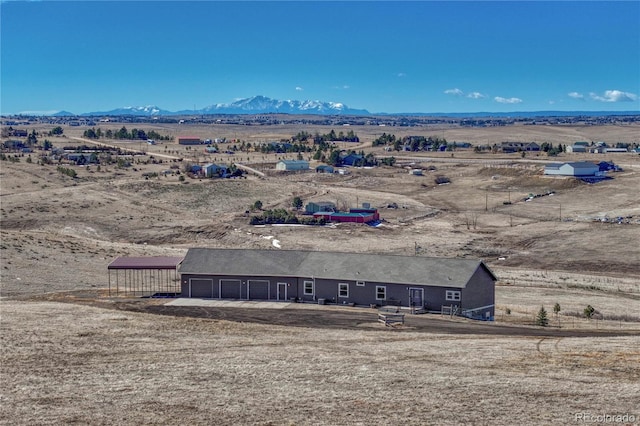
[15,96,640,118]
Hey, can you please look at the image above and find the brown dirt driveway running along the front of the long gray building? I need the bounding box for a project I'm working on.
[31,291,640,338]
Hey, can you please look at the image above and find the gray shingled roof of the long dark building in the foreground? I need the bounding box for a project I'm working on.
[179,248,497,287]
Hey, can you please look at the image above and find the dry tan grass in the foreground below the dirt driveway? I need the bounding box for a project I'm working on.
[0,301,640,425]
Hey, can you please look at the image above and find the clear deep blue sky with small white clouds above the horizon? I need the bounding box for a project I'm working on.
[0,1,640,114]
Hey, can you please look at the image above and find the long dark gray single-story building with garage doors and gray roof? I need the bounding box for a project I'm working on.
[178,248,497,319]
